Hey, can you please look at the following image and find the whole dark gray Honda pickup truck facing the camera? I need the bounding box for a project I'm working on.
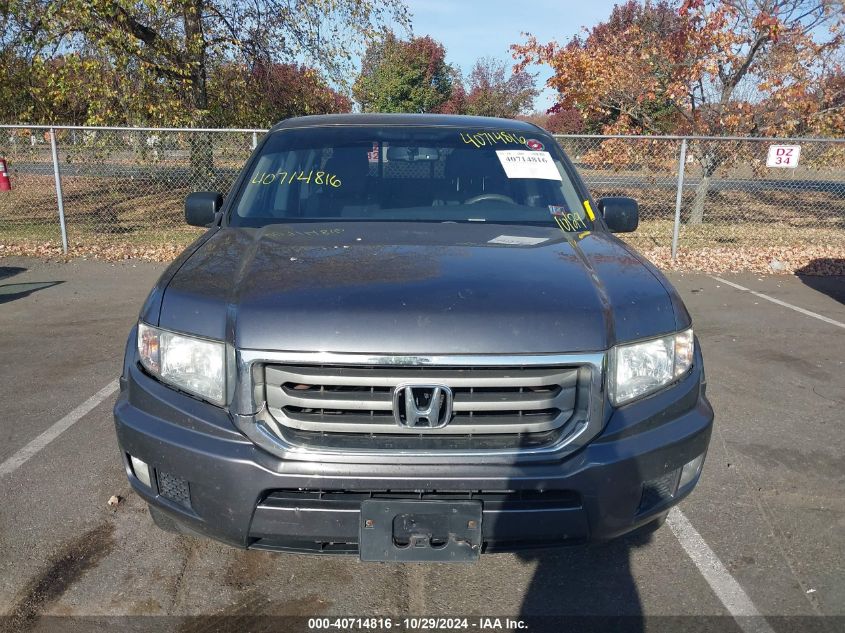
[114,115,713,562]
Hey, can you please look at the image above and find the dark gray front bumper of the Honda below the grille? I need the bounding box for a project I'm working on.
[114,356,713,553]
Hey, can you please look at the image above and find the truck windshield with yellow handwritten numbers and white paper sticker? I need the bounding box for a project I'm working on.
[229,126,594,232]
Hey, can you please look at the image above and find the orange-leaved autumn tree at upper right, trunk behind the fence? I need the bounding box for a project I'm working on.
[512,0,845,224]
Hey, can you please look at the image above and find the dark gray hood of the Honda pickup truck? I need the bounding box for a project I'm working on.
[152,222,690,355]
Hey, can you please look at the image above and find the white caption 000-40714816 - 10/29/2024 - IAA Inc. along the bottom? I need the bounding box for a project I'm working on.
[308,616,528,633]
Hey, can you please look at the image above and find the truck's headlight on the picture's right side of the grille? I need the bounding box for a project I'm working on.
[608,329,695,405]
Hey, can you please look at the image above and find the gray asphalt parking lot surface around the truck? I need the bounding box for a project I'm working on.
[0,258,845,632]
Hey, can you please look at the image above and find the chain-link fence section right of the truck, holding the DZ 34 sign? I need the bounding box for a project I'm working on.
[558,136,845,251]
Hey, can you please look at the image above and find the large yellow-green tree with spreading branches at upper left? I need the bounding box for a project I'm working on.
[0,0,409,126]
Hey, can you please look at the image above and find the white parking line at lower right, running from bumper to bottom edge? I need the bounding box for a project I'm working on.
[666,506,774,633]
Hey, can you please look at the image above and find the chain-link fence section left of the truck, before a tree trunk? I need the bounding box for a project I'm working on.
[0,126,264,252]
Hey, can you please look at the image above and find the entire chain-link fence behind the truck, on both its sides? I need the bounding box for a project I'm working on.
[0,126,845,260]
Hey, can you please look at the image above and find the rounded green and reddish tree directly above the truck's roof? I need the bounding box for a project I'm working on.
[352,31,454,112]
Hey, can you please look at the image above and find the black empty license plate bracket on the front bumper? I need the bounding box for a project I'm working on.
[358,499,482,563]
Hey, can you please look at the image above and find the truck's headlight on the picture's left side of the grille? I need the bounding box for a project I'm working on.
[138,323,226,405]
